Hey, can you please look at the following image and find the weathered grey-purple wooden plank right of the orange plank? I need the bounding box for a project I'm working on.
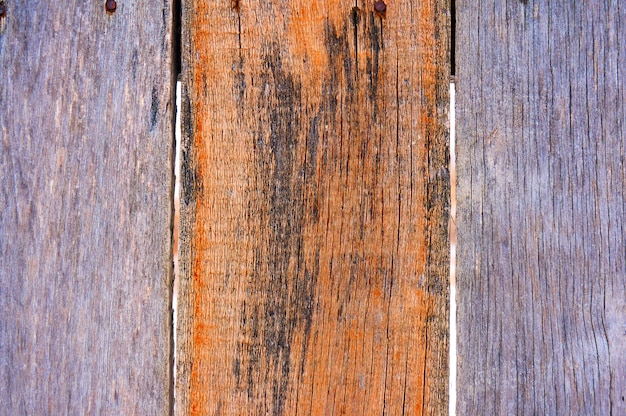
[456,0,626,415]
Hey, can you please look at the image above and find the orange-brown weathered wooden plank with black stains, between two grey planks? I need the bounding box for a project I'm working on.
[177,0,450,415]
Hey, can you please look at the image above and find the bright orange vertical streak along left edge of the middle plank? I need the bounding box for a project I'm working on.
[189,1,234,415]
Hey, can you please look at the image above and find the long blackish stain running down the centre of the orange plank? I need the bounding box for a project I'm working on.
[235,44,317,415]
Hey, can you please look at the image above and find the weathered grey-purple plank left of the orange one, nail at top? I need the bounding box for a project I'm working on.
[0,0,173,415]
